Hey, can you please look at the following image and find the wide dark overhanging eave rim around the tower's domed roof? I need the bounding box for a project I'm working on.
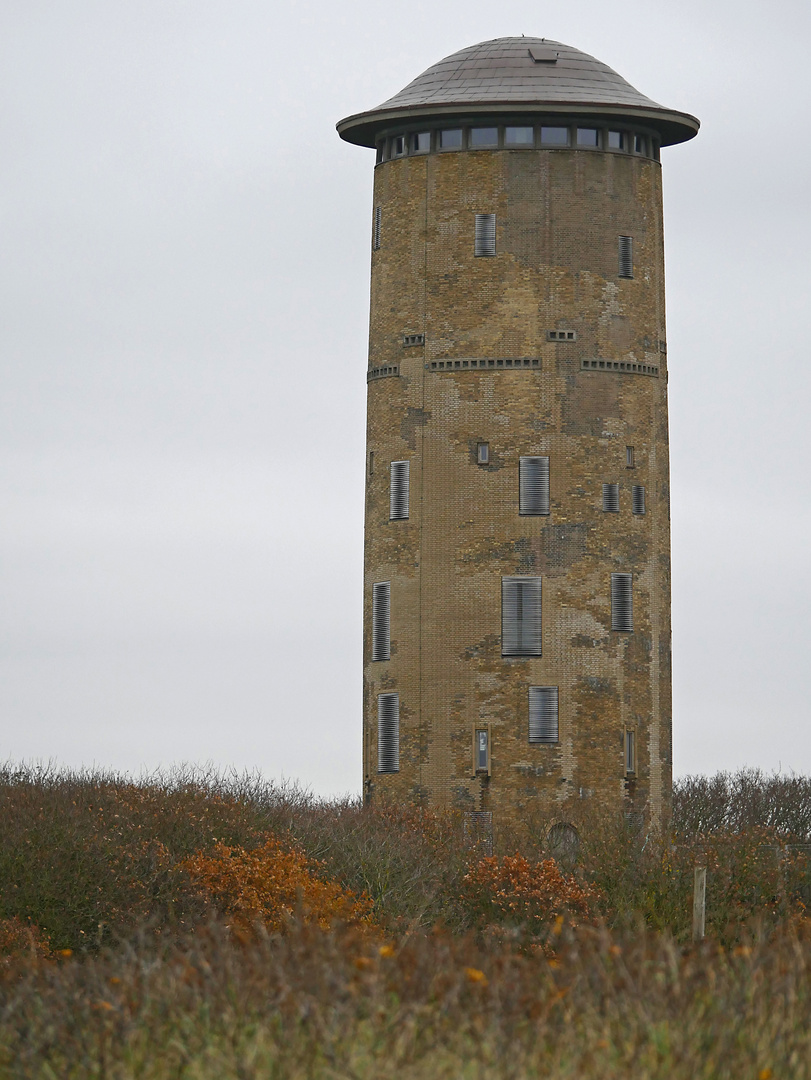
[336,100,700,148]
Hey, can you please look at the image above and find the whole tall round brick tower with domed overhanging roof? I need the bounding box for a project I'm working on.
[338,38,699,818]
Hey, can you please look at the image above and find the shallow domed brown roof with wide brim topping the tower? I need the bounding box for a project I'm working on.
[337,38,699,146]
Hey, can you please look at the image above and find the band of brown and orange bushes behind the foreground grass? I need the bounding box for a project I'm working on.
[0,767,811,950]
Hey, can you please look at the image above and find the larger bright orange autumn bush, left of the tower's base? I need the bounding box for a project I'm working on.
[180,839,371,931]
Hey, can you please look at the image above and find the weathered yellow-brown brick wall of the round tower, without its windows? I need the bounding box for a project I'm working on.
[364,141,671,816]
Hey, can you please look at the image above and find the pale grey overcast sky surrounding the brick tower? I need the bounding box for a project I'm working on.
[0,0,811,794]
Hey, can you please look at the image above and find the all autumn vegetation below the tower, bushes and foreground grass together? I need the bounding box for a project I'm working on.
[0,768,811,1080]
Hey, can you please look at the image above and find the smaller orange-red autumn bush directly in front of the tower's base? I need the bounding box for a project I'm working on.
[463,854,596,928]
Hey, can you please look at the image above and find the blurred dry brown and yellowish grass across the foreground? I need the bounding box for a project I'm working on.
[0,923,811,1080]
